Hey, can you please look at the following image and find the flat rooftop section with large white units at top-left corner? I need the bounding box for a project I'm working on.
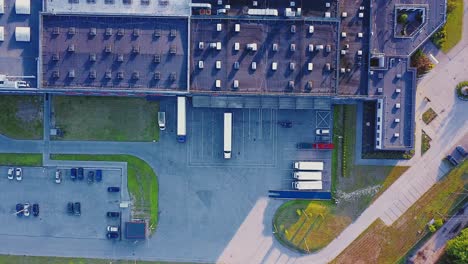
[0,0,42,87]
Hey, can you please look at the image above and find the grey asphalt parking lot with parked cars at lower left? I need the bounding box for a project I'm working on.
[0,166,121,239]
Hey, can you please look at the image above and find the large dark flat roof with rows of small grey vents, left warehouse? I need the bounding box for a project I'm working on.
[42,15,188,91]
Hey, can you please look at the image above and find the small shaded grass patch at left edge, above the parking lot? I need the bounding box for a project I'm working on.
[0,95,44,139]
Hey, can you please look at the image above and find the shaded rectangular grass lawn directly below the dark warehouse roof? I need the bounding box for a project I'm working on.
[53,96,159,141]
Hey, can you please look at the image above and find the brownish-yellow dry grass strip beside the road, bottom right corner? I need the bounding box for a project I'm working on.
[333,161,468,263]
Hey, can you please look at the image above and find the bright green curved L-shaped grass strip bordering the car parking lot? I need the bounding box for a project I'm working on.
[51,154,159,231]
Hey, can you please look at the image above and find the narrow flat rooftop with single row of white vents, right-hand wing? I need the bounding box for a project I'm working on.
[369,58,416,150]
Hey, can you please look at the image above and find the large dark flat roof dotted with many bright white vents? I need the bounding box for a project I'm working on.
[190,17,338,95]
